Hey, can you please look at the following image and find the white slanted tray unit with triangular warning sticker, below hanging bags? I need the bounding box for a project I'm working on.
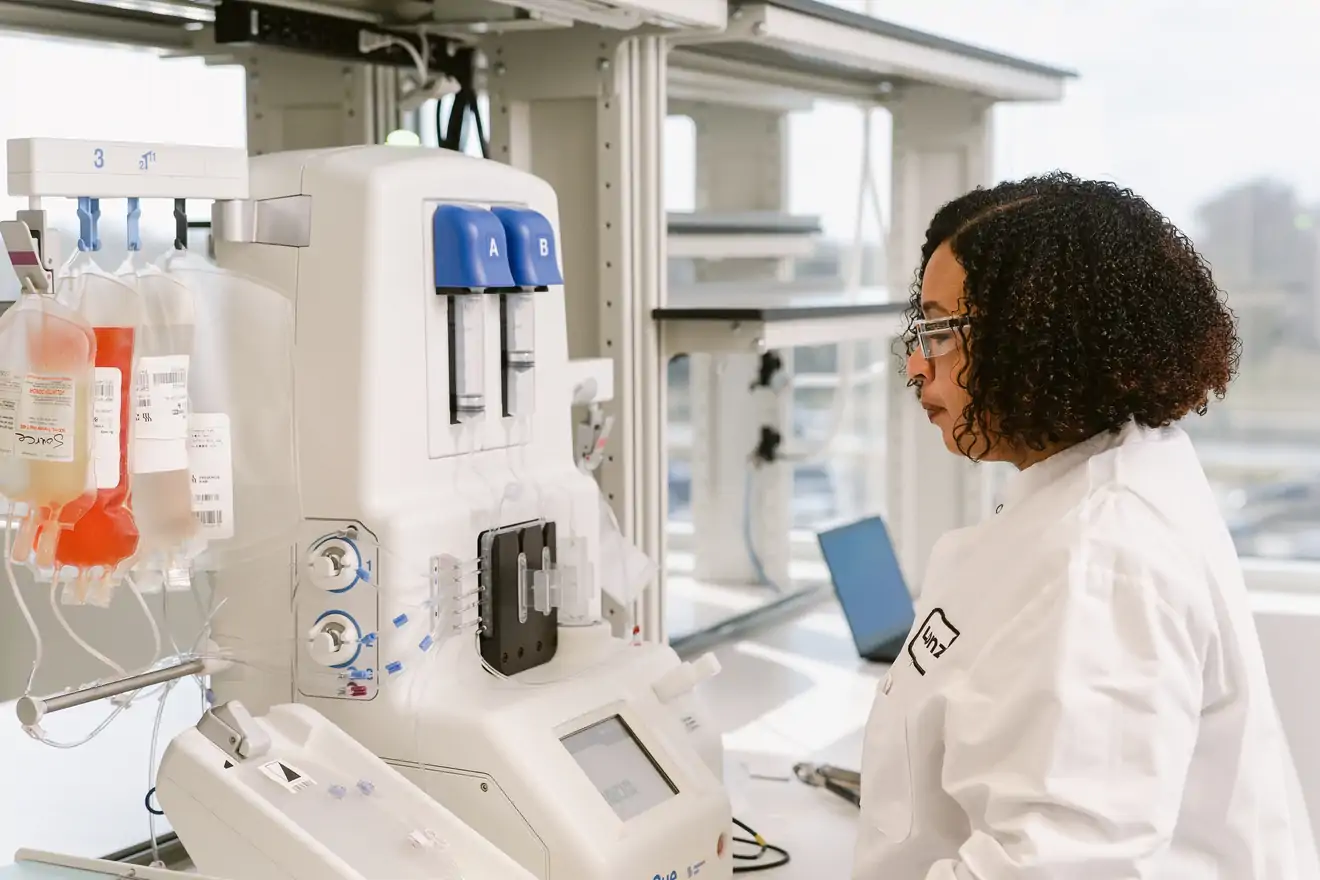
[156,702,531,880]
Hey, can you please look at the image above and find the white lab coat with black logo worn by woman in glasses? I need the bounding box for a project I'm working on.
[853,425,1320,880]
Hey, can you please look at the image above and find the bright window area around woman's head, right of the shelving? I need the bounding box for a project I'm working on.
[850,0,1320,572]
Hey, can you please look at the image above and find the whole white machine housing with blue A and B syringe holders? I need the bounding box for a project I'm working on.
[213,146,733,880]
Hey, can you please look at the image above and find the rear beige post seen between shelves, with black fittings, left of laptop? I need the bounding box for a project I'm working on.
[671,102,793,590]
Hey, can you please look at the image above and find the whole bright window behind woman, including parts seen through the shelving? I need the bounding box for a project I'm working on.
[665,0,1320,646]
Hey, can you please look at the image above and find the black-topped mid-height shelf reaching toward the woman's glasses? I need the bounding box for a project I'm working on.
[651,284,907,356]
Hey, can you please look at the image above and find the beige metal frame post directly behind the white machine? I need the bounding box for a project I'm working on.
[482,25,668,641]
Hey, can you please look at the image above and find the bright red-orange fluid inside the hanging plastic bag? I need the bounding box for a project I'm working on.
[55,327,139,583]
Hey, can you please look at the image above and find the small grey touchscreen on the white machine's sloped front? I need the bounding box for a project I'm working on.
[560,715,678,822]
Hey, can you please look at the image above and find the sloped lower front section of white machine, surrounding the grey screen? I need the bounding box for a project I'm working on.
[374,624,733,880]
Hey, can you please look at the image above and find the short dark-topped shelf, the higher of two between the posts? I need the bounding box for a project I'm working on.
[668,211,821,260]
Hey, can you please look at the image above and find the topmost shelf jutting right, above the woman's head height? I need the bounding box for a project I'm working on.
[671,0,1076,100]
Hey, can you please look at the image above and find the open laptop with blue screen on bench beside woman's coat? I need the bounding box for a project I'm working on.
[816,516,916,664]
